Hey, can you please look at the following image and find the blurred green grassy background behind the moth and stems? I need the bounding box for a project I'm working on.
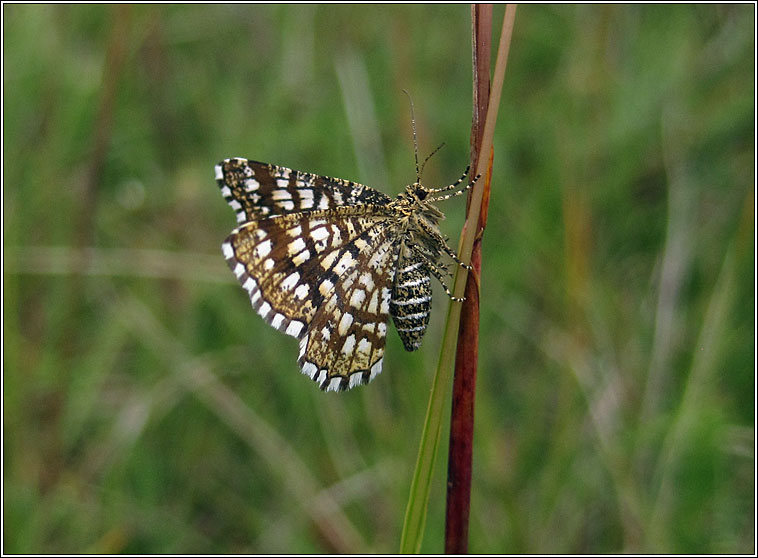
[3,4,755,554]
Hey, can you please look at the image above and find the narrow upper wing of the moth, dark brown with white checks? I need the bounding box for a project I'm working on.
[216,158,390,223]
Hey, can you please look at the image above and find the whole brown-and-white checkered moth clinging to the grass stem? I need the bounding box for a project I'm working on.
[216,159,476,391]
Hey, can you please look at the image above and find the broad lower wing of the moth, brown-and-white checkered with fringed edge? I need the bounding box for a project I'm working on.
[222,205,397,390]
